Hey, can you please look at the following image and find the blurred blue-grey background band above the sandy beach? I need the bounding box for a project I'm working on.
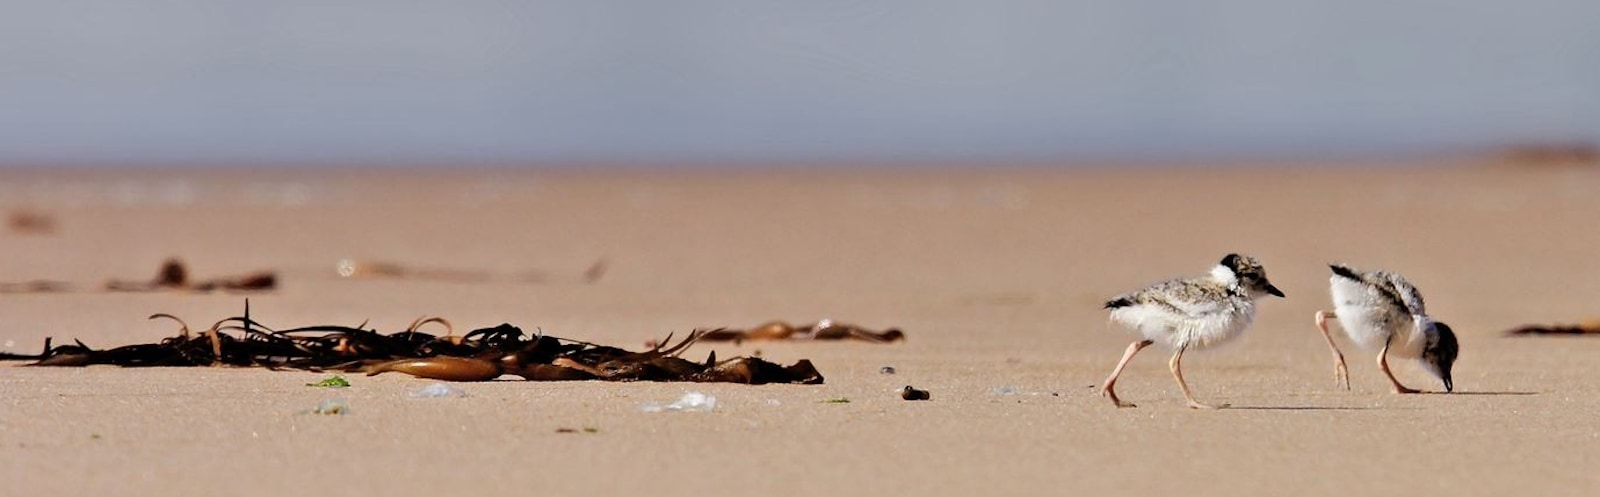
[0,0,1600,165]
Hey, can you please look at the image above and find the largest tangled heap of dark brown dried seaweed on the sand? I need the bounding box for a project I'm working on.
[0,302,822,385]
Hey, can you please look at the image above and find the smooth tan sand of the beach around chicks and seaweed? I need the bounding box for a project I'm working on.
[0,165,1600,495]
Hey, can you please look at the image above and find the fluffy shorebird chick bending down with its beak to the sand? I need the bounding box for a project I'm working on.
[1317,264,1461,393]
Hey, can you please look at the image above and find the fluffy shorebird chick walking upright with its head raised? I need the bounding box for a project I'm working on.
[1101,254,1283,409]
